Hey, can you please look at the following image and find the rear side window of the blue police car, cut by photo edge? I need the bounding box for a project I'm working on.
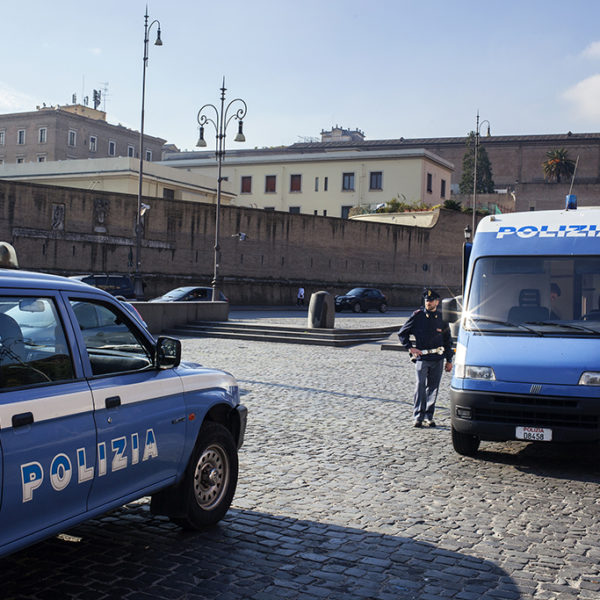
[0,296,75,391]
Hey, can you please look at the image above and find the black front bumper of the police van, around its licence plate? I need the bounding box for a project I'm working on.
[450,388,600,442]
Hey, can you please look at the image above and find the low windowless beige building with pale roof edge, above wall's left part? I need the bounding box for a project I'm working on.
[0,157,234,204]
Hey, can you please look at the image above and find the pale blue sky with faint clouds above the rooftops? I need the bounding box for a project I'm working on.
[0,0,600,150]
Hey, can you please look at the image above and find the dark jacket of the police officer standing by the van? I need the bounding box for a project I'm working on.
[398,308,453,362]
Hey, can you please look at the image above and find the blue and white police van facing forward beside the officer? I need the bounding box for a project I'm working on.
[442,197,600,455]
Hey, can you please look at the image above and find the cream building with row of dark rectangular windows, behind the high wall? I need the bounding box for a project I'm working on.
[161,146,454,218]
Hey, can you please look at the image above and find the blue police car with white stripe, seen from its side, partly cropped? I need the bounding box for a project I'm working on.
[0,252,247,555]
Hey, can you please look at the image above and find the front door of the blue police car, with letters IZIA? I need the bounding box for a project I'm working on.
[69,296,185,509]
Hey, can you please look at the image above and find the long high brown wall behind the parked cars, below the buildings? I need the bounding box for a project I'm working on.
[0,181,471,306]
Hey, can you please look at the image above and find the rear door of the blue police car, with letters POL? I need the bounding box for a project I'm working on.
[0,291,96,548]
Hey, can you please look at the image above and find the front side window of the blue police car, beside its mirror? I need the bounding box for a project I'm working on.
[71,300,153,375]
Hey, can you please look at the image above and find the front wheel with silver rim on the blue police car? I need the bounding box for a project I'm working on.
[174,422,238,530]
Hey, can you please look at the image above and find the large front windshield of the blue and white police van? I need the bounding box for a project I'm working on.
[464,256,600,335]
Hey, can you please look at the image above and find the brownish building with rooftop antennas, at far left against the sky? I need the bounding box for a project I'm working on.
[0,104,166,164]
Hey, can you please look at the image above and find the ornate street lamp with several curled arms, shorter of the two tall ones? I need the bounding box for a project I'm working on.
[196,77,248,302]
